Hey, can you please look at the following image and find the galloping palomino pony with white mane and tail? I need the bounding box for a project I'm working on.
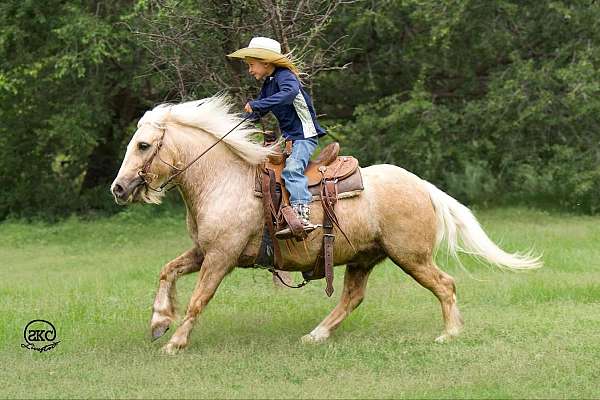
[111,96,541,354]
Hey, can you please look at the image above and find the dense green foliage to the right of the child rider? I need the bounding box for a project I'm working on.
[319,0,600,212]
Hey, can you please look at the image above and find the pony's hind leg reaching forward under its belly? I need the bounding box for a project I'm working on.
[302,263,374,343]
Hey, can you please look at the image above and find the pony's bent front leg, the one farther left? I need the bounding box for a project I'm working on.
[150,247,203,340]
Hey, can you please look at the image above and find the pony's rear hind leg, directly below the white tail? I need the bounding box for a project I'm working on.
[390,255,463,343]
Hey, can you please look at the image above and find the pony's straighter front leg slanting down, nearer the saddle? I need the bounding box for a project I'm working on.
[163,250,235,354]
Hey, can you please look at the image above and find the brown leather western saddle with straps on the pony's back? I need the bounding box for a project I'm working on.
[255,141,363,296]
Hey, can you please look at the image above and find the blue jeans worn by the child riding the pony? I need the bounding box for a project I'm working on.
[281,137,319,206]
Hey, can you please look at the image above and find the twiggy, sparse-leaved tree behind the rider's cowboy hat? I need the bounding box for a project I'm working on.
[130,0,353,101]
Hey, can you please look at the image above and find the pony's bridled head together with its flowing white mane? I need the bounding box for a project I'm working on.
[110,95,274,204]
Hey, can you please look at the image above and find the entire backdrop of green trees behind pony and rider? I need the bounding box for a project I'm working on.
[0,0,600,219]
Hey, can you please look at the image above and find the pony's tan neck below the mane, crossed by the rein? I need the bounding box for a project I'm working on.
[168,127,256,211]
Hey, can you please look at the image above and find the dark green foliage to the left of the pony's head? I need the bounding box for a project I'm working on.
[0,0,149,218]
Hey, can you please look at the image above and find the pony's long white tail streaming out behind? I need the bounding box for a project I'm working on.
[425,182,542,270]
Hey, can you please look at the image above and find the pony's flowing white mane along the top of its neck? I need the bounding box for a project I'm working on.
[138,95,273,165]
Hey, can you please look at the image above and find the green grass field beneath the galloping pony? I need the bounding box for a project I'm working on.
[0,206,600,398]
